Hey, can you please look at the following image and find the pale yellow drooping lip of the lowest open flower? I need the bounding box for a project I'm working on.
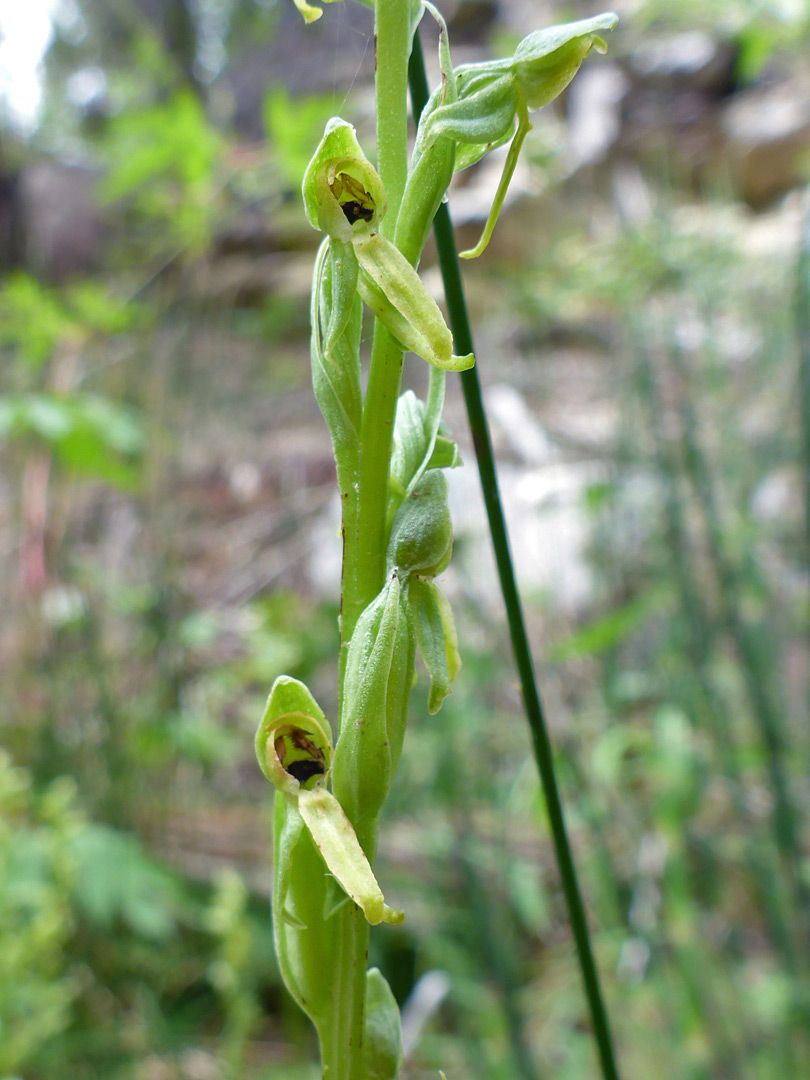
[298,787,405,926]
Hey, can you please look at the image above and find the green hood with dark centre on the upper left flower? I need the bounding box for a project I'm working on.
[302,117,387,243]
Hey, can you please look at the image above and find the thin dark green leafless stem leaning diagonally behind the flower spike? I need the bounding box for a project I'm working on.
[409,33,619,1080]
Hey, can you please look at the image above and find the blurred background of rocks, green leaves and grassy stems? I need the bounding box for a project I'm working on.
[0,0,810,1080]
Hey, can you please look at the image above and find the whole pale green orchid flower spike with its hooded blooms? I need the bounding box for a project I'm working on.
[256,0,616,1080]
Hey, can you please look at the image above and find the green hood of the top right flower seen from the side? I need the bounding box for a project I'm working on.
[512,12,619,109]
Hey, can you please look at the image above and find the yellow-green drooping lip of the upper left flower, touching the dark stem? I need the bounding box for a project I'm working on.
[353,233,475,372]
